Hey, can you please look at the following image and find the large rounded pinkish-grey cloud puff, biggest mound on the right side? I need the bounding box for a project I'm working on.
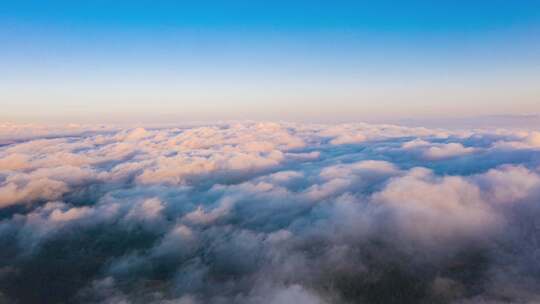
[375,168,500,246]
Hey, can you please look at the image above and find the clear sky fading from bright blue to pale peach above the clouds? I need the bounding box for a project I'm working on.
[0,0,540,123]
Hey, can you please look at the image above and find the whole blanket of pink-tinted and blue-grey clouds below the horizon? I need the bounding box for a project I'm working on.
[0,122,540,304]
